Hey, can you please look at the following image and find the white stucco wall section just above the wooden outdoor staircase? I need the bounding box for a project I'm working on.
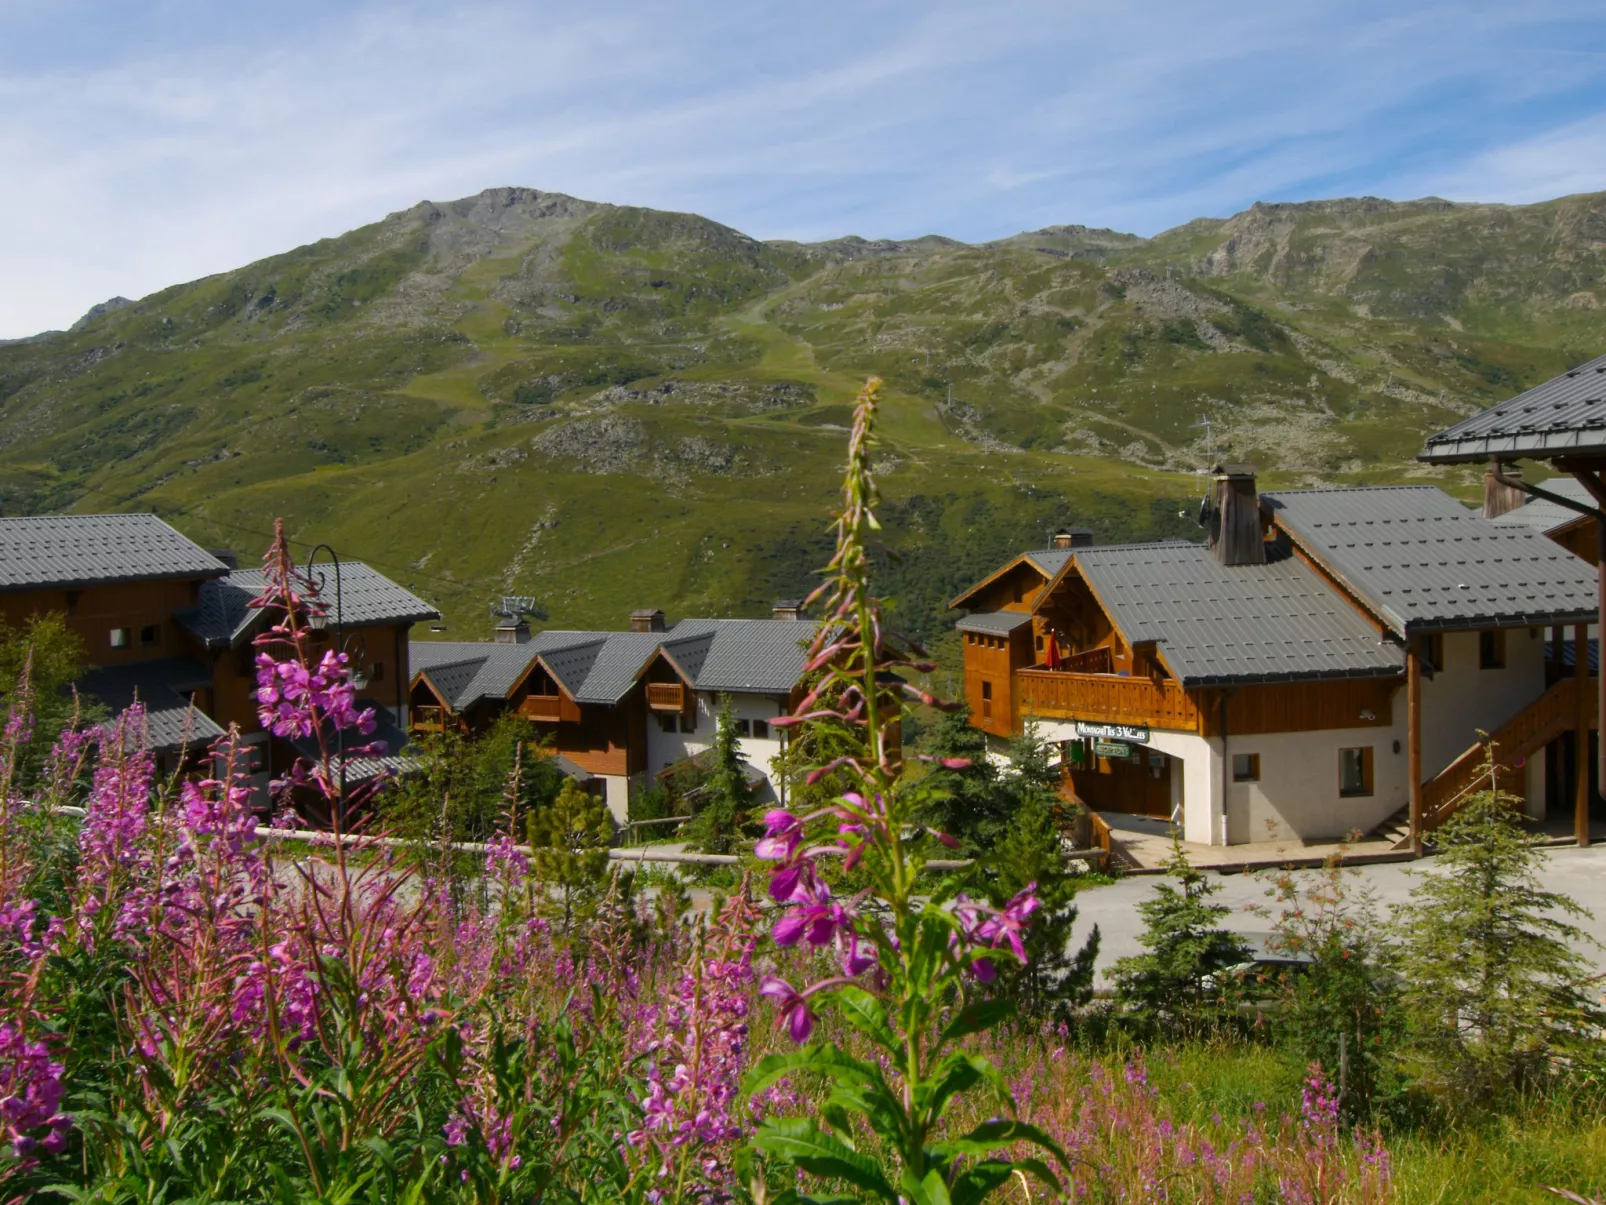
[1426,628,1545,778]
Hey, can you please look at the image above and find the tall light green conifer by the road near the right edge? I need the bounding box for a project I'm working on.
[1397,749,1606,1102]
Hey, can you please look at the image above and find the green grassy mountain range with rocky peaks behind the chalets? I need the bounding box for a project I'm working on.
[0,188,1606,635]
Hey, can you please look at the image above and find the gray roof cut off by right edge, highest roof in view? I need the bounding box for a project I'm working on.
[1418,355,1606,464]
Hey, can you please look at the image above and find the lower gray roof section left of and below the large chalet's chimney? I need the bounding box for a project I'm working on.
[1076,540,1404,686]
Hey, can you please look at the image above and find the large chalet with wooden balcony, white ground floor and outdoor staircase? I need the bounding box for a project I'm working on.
[952,466,1593,844]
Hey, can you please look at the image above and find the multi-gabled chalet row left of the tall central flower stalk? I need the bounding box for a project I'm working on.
[410,604,811,821]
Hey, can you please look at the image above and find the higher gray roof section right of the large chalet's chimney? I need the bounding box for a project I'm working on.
[1261,485,1595,635]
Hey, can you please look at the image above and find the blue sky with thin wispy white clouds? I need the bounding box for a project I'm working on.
[0,0,1606,337]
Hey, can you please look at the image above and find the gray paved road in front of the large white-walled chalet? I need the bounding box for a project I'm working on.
[1071,845,1606,986]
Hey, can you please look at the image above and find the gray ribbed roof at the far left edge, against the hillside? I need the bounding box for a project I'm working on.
[0,514,228,591]
